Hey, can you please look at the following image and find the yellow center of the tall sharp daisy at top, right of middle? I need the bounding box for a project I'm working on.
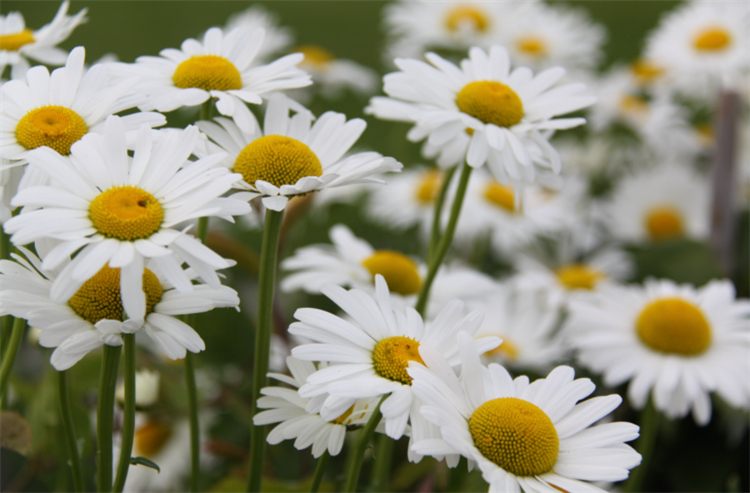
[456,80,523,127]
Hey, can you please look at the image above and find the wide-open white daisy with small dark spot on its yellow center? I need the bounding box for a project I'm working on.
[5,116,249,308]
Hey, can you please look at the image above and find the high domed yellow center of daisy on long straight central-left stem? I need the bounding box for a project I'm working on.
[234,135,323,187]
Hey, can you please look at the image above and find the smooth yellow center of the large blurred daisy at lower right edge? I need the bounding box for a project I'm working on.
[635,298,711,356]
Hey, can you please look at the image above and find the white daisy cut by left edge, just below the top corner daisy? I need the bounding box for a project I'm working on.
[0,46,167,167]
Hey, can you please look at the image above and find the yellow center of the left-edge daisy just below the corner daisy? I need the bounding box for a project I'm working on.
[16,106,89,156]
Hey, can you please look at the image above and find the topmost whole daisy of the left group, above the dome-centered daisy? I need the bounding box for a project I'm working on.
[116,27,311,132]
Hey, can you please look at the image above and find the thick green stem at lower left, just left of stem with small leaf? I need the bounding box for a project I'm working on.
[96,344,122,492]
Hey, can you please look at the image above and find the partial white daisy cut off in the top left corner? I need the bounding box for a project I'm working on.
[0,0,87,79]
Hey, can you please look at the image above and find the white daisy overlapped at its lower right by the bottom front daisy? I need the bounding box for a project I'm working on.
[289,276,500,439]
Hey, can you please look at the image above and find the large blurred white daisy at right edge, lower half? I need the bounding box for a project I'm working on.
[566,279,750,425]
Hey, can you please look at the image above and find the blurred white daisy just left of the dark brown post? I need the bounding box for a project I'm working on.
[606,164,710,242]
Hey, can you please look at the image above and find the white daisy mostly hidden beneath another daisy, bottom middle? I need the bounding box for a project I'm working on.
[253,356,377,459]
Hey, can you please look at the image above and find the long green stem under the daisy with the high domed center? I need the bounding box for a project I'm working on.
[247,209,284,491]
